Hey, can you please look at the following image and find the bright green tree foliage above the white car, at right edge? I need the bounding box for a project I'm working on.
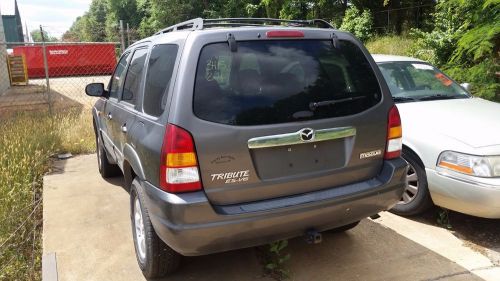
[412,0,500,100]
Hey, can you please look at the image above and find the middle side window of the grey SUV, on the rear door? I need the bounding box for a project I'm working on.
[121,48,148,104]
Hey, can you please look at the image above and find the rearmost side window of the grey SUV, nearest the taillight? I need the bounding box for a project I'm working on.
[143,44,179,116]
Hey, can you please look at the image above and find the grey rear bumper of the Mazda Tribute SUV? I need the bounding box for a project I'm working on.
[142,159,406,256]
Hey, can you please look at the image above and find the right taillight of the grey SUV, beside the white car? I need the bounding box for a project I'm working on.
[384,105,403,159]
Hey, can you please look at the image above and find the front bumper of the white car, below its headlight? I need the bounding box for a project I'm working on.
[426,169,500,219]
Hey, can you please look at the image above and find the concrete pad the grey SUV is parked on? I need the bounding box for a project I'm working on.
[43,155,480,281]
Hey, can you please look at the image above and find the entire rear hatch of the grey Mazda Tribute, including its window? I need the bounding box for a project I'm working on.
[180,32,390,205]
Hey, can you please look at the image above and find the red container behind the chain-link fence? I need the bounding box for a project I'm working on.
[13,43,116,78]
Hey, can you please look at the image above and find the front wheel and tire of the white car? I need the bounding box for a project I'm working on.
[391,149,433,216]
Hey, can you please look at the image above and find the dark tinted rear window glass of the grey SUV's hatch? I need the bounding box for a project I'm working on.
[193,40,381,125]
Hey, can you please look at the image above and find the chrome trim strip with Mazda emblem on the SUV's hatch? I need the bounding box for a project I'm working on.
[248,127,356,149]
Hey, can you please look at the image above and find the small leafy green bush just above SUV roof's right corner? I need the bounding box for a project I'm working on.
[340,6,373,42]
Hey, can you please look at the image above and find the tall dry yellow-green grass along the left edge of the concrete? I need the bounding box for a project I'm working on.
[0,108,95,280]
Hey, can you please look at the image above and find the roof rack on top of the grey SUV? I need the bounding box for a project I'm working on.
[155,18,335,35]
